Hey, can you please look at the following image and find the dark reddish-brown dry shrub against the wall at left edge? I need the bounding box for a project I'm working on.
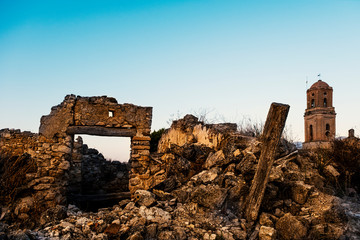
[0,154,36,204]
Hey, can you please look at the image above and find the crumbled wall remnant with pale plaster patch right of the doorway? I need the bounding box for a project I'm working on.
[138,115,248,191]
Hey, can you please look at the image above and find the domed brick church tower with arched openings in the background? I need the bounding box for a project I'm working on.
[303,80,336,149]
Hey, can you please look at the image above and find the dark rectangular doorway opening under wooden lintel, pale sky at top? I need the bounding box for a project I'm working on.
[74,134,131,211]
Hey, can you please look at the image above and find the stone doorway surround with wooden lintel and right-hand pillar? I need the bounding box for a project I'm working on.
[39,95,152,193]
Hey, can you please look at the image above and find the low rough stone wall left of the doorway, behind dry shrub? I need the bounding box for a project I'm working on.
[0,129,71,224]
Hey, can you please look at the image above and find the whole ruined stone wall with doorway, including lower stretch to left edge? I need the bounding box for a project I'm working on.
[0,95,152,219]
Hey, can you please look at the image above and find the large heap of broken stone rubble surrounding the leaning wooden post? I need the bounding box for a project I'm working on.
[0,116,360,240]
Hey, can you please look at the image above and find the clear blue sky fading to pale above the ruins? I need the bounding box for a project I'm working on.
[0,0,360,161]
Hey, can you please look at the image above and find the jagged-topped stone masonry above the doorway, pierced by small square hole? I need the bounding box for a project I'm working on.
[39,95,152,138]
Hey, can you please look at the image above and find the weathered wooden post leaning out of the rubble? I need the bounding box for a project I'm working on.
[243,103,290,222]
